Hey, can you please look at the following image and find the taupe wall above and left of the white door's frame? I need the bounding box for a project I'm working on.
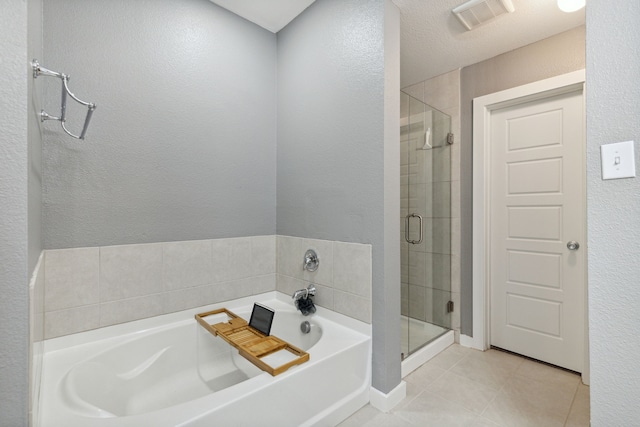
[460,26,585,336]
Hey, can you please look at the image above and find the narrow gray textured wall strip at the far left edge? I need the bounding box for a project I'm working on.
[0,0,31,426]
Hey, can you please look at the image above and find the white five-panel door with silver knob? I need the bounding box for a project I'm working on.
[489,90,586,372]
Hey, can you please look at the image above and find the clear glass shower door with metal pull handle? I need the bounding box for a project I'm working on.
[400,92,454,359]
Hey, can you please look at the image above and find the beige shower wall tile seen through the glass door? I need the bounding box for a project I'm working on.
[401,111,451,327]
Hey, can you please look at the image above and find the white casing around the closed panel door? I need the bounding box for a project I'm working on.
[460,69,589,383]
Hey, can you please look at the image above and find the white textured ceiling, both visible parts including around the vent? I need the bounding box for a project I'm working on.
[211,0,585,87]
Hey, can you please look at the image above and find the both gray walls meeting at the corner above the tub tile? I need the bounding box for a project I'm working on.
[43,0,400,391]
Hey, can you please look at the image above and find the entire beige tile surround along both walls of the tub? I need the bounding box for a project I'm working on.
[42,235,372,338]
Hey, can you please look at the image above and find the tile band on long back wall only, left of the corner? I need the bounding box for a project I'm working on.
[44,236,276,338]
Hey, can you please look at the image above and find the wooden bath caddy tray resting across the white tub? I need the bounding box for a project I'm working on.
[195,308,309,376]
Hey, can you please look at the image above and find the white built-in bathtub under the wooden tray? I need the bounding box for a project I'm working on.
[40,292,371,427]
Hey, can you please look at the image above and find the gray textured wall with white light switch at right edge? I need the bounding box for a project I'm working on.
[586,1,640,426]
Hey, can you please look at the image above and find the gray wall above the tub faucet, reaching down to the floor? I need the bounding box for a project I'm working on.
[277,0,400,393]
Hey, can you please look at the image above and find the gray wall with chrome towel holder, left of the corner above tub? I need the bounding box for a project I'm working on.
[41,0,276,249]
